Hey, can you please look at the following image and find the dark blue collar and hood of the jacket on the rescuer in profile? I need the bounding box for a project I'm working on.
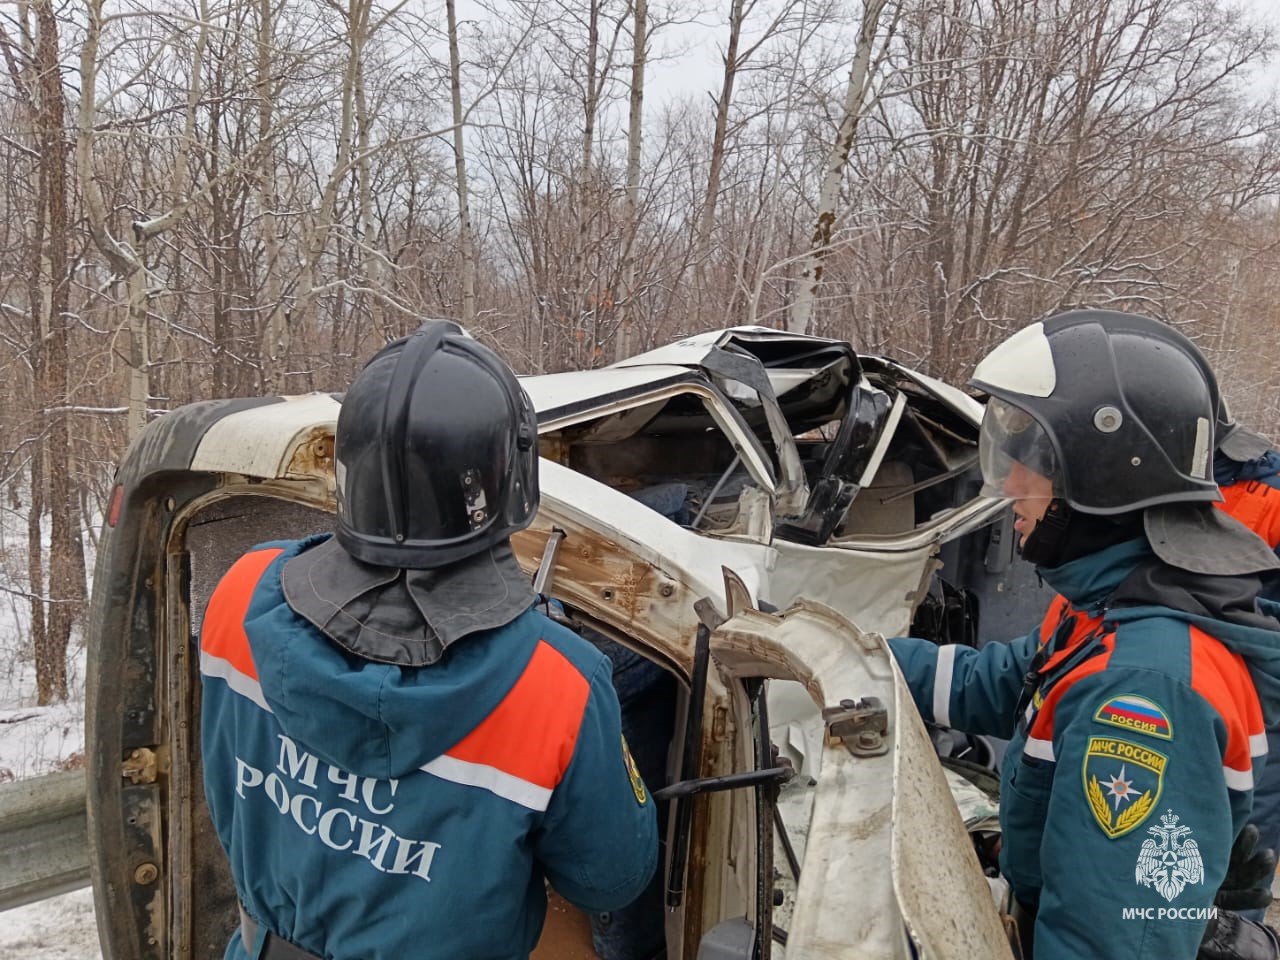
[1038,539,1280,726]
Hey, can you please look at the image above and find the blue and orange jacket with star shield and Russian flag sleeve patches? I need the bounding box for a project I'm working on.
[890,540,1280,960]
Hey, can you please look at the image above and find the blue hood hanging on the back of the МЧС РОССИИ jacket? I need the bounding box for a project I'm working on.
[244,541,541,780]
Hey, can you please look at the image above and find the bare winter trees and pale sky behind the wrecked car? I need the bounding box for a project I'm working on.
[0,0,1280,707]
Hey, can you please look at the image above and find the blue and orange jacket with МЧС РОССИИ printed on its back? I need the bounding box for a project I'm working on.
[200,540,657,960]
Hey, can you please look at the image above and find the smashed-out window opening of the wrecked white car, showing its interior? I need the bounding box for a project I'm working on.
[540,353,978,544]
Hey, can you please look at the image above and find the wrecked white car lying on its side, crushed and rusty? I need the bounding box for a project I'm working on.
[88,328,1010,960]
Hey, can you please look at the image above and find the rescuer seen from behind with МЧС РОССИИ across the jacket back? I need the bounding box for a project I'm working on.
[200,321,657,960]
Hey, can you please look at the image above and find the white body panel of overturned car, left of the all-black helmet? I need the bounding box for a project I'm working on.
[191,393,342,477]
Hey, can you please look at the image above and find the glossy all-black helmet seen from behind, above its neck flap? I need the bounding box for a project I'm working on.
[334,320,538,570]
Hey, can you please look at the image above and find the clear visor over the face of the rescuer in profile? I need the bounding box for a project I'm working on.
[978,397,1062,500]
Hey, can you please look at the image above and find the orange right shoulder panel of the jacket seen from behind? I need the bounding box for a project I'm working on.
[445,640,590,790]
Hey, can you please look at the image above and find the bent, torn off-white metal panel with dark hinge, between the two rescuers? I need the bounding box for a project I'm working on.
[712,609,1010,960]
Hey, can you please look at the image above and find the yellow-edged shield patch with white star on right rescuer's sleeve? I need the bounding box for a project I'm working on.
[1080,737,1169,840]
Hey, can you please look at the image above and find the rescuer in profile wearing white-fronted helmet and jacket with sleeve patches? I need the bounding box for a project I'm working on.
[891,310,1280,960]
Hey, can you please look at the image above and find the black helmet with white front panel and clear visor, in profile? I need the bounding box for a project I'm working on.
[969,310,1221,516]
